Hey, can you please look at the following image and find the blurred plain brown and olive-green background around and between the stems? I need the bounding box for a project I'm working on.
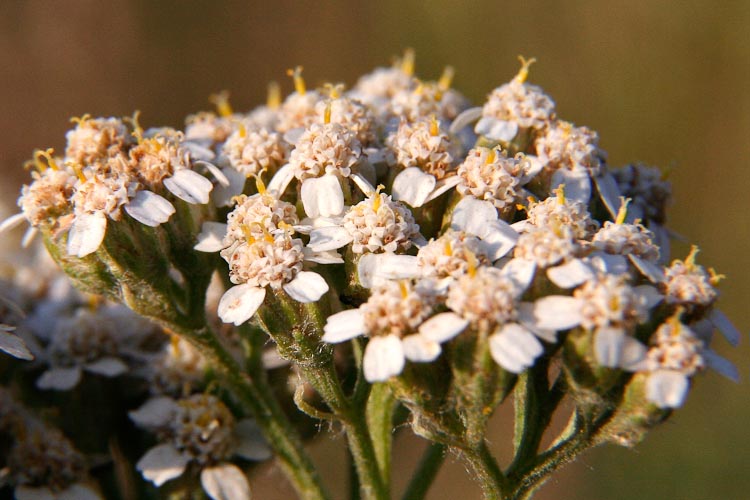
[0,0,750,500]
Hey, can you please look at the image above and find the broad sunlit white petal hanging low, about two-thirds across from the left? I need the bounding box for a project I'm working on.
[489,323,544,373]
